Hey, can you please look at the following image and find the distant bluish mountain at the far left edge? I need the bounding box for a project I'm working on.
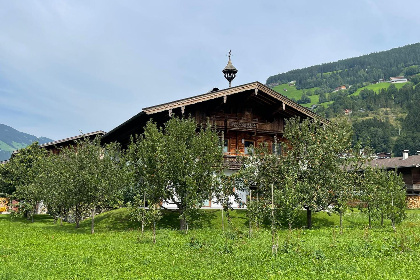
[0,124,53,161]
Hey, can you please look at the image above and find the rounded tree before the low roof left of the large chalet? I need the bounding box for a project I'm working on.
[60,137,126,234]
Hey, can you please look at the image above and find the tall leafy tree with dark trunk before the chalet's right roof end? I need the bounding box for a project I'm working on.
[284,118,352,228]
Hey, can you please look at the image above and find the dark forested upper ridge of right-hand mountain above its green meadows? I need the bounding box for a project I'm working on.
[266,43,420,92]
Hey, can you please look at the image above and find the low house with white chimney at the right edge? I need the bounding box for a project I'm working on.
[371,150,420,208]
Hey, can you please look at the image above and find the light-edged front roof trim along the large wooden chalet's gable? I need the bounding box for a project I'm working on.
[143,82,325,121]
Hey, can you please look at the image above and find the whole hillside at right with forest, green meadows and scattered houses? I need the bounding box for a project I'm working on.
[267,43,420,156]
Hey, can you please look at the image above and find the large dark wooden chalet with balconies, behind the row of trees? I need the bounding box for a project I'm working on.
[102,82,326,208]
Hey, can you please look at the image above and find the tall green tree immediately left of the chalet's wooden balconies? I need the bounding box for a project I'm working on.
[162,118,223,231]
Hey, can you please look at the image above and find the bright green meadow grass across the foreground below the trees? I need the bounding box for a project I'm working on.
[0,209,420,279]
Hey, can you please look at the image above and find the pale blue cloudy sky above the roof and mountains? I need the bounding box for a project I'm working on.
[0,0,420,140]
